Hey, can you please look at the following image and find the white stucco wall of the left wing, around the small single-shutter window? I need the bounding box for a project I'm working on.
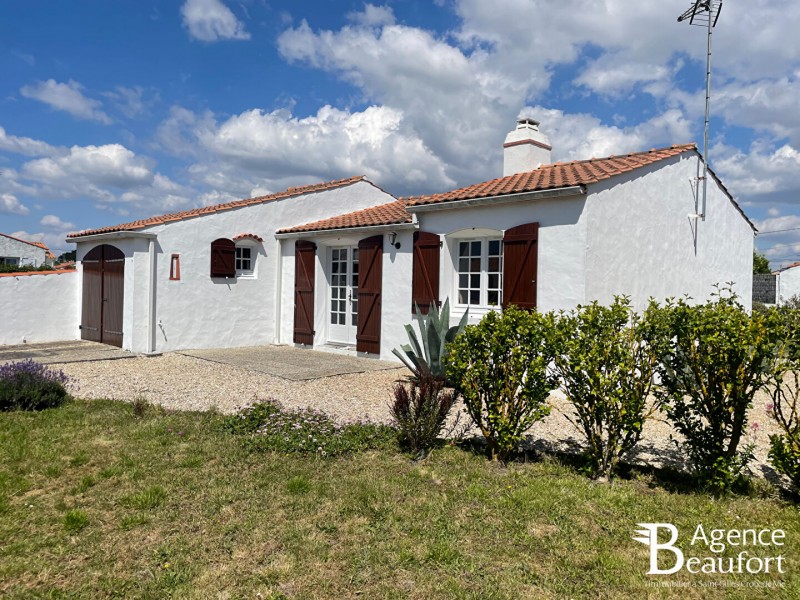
[78,181,393,352]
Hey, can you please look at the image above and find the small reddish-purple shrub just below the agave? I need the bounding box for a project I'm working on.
[390,374,457,454]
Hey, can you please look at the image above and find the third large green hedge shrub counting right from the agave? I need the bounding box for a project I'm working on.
[645,291,784,493]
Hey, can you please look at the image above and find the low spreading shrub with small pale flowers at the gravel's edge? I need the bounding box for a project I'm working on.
[224,400,396,456]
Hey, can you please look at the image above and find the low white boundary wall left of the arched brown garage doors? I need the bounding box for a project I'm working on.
[0,271,80,344]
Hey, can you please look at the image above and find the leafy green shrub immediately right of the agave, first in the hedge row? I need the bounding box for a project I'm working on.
[447,306,558,461]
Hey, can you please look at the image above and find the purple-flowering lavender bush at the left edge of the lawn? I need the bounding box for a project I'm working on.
[0,360,70,411]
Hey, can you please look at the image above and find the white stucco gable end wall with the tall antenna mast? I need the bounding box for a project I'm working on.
[586,154,753,309]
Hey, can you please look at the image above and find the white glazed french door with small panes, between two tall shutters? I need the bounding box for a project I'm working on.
[328,246,358,345]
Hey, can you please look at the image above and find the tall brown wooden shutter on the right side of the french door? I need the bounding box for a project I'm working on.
[356,235,383,354]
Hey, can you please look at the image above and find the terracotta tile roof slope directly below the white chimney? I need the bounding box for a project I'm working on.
[406,144,697,208]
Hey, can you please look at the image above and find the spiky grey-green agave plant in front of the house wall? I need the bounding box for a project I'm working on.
[392,299,469,380]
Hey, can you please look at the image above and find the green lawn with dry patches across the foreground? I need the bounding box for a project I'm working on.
[0,401,800,599]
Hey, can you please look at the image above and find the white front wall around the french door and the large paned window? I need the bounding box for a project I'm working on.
[279,197,585,360]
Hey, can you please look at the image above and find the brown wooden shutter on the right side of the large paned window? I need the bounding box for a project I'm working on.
[503,223,539,310]
